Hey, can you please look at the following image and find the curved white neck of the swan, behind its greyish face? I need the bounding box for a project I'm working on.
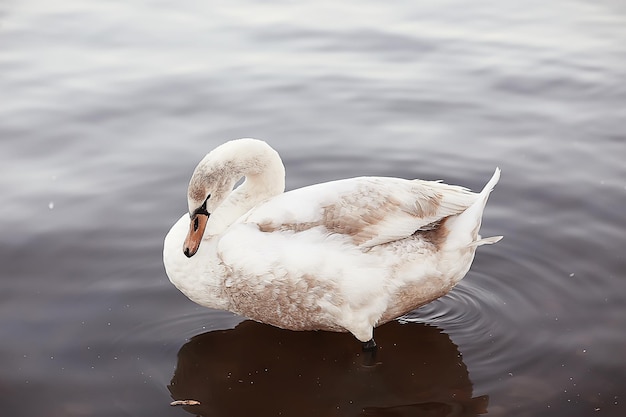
[204,139,285,239]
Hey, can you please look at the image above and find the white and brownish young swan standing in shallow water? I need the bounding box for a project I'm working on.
[163,138,502,349]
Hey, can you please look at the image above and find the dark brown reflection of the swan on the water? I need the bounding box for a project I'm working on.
[169,321,488,417]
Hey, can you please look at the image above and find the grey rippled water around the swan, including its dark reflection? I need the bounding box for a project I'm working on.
[0,0,626,416]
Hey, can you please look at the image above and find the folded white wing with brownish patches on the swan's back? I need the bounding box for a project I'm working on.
[241,177,477,248]
